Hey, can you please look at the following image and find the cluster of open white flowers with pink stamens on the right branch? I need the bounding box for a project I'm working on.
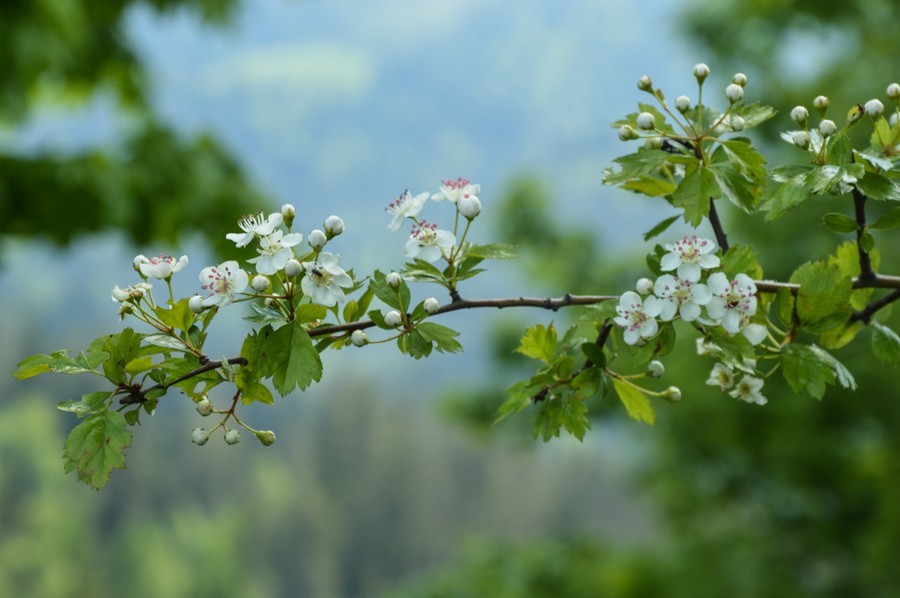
[614,235,766,345]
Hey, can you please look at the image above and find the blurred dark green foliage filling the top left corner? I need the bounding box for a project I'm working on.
[0,0,265,250]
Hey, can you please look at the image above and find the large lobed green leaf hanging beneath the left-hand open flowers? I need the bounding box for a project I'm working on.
[259,320,322,396]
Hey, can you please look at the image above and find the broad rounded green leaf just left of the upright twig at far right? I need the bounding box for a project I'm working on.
[791,262,853,332]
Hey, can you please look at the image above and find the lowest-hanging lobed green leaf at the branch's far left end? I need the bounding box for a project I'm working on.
[63,409,131,490]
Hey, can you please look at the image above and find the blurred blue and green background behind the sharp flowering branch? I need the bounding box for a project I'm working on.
[0,0,900,597]
